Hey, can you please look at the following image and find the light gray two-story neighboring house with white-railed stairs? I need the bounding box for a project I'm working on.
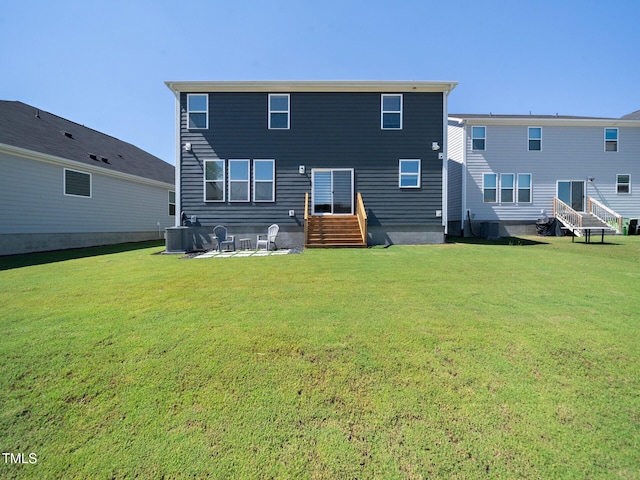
[448,114,640,236]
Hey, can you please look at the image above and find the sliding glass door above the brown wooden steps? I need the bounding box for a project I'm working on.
[311,168,353,215]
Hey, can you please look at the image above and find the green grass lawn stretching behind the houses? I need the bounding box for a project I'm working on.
[0,237,640,479]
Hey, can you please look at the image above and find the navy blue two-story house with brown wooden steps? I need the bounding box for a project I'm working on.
[166,81,457,249]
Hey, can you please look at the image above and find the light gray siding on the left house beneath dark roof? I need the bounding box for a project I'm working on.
[0,154,174,234]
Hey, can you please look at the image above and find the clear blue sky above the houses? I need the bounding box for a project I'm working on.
[0,0,640,163]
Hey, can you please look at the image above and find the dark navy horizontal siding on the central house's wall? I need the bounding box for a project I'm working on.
[180,92,443,227]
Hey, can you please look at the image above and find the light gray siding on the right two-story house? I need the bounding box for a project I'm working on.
[462,124,640,221]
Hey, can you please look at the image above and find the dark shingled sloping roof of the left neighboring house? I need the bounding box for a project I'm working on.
[0,100,175,184]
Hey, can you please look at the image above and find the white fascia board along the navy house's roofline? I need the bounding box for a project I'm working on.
[164,80,458,94]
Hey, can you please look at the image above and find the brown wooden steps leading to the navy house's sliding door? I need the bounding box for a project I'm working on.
[305,215,367,248]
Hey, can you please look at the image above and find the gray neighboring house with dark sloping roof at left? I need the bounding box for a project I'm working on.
[0,101,175,255]
